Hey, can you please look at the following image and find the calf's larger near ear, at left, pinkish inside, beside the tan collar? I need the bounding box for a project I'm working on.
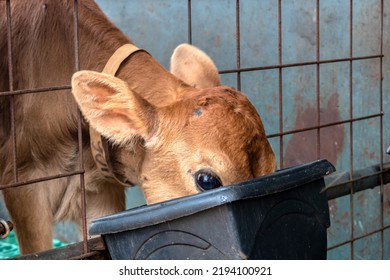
[72,71,157,144]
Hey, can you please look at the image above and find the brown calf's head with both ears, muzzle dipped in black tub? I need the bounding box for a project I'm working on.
[72,45,276,204]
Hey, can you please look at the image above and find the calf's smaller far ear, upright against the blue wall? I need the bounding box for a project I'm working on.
[170,44,221,88]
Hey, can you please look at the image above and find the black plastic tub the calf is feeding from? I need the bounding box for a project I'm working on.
[90,160,335,260]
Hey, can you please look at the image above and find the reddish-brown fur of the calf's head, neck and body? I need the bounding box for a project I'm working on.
[0,0,275,253]
